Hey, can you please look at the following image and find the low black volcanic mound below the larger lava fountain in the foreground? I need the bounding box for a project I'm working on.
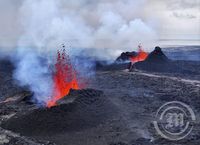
[2,89,114,137]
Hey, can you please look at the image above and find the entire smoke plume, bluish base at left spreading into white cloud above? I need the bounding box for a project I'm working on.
[14,0,156,103]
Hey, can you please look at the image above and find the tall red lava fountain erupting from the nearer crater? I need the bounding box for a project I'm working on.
[47,50,79,107]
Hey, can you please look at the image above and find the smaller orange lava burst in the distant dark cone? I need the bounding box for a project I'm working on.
[130,47,148,63]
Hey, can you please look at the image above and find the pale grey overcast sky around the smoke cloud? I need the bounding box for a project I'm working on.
[0,0,200,47]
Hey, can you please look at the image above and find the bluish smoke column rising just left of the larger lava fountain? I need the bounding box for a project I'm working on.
[13,48,53,105]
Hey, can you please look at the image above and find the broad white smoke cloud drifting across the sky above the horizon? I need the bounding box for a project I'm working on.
[19,0,156,59]
